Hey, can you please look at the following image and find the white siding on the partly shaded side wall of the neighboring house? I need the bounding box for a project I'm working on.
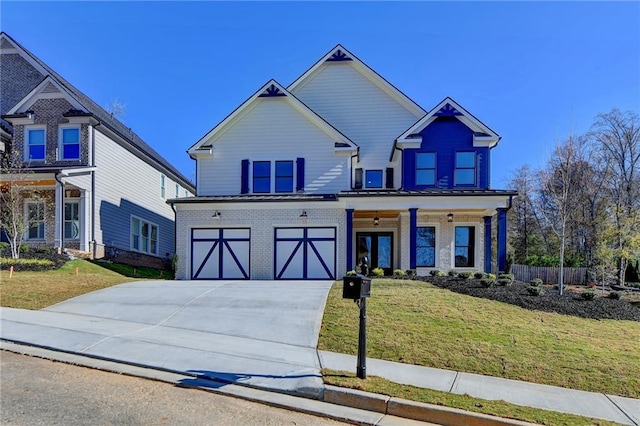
[95,128,179,257]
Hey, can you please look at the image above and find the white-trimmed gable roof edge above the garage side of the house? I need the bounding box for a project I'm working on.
[187,79,358,158]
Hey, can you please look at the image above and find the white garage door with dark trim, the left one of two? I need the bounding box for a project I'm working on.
[191,228,251,280]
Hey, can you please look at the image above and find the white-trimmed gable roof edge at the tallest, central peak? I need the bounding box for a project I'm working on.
[287,44,426,118]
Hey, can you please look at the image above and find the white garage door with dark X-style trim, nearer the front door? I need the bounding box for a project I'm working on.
[274,228,336,280]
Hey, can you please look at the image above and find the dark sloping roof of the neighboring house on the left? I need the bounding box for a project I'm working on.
[0,32,195,191]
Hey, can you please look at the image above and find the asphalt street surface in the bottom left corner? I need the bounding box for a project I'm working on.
[0,351,342,426]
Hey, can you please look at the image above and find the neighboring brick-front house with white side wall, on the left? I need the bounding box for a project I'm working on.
[0,33,195,266]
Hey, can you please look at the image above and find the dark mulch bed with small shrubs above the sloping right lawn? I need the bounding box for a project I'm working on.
[400,276,640,321]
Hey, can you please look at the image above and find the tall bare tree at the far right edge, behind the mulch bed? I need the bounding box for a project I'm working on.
[590,109,640,285]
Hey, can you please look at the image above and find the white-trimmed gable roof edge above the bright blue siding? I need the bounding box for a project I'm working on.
[396,97,500,148]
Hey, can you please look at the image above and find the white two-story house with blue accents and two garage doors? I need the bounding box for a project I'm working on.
[169,45,516,280]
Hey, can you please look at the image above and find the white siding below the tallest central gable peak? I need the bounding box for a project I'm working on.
[292,61,421,178]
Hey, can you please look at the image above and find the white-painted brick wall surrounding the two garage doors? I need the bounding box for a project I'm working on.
[176,204,346,280]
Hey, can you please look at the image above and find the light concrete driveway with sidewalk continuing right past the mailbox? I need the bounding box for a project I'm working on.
[0,281,640,425]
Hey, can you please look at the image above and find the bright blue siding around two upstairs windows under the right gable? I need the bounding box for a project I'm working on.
[403,116,491,189]
